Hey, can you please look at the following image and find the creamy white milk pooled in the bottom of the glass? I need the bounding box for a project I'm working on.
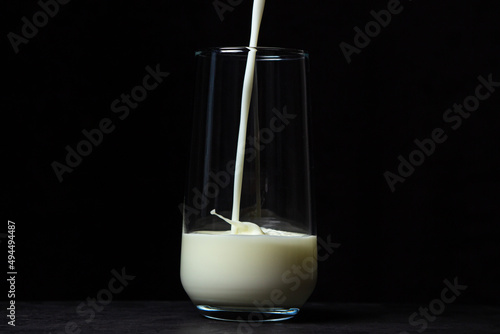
[181,229,317,309]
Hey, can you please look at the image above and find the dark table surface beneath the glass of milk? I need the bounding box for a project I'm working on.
[0,301,500,334]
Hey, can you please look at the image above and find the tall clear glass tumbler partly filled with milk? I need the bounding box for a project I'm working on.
[181,47,317,322]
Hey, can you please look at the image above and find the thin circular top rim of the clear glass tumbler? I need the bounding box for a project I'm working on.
[195,46,309,59]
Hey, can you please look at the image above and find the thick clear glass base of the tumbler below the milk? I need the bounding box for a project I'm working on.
[196,305,299,322]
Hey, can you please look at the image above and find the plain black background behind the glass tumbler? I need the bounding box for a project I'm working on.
[0,0,500,304]
